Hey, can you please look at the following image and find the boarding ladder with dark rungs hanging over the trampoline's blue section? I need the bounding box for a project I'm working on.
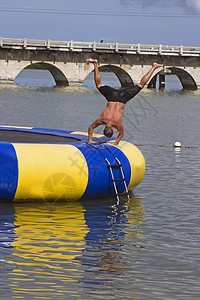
[90,144,130,204]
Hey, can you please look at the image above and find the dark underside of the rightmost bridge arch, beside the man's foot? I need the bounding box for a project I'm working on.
[148,67,198,90]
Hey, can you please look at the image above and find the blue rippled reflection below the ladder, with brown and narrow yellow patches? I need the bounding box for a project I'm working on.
[78,196,145,299]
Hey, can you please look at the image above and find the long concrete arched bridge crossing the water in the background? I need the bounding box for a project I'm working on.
[0,38,200,90]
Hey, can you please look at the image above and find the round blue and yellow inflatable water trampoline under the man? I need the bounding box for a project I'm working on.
[0,126,145,201]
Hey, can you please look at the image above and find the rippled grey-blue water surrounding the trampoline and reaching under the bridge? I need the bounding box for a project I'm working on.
[0,70,200,300]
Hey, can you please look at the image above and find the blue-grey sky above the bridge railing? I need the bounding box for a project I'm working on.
[0,0,200,47]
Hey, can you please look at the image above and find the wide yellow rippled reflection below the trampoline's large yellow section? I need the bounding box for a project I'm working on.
[9,202,88,297]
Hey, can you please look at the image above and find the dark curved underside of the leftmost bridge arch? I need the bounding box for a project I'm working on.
[18,62,69,86]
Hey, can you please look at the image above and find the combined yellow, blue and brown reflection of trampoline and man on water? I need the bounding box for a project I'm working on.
[2,197,145,299]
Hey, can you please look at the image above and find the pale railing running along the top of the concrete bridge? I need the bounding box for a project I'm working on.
[0,37,200,56]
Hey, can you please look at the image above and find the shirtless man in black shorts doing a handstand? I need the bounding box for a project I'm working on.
[87,58,163,146]
